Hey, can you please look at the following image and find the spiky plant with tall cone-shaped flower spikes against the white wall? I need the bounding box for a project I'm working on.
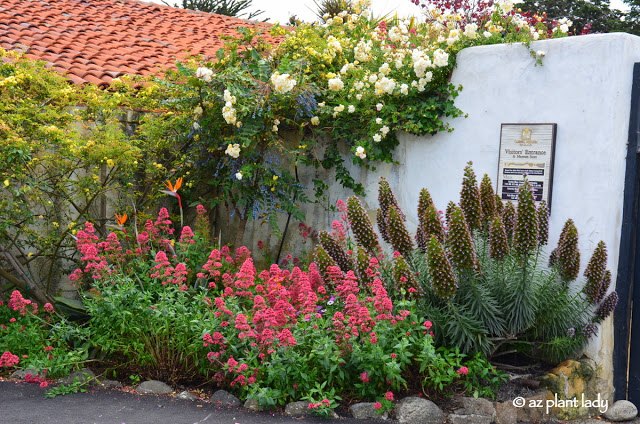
[315,163,618,361]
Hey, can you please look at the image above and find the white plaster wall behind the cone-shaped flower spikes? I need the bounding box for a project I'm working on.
[248,34,640,396]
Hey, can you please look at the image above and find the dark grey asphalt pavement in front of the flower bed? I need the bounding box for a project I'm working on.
[0,381,381,424]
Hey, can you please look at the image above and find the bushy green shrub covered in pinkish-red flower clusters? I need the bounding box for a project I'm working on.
[69,205,500,404]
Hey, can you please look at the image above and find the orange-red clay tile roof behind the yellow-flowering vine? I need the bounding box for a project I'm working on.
[0,0,274,87]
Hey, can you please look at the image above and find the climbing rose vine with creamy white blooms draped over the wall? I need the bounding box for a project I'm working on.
[114,1,561,238]
